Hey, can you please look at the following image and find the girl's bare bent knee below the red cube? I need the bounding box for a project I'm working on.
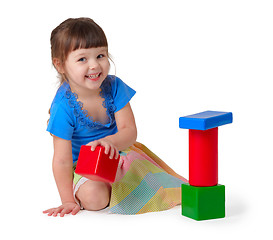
[76,180,111,211]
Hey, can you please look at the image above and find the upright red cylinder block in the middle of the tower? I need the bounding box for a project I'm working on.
[189,128,218,187]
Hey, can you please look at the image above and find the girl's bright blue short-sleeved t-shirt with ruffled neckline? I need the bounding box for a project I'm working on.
[47,75,136,162]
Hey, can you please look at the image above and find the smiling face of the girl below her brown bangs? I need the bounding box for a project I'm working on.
[64,47,110,93]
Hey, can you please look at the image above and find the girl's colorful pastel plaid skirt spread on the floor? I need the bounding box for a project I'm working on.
[74,142,188,215]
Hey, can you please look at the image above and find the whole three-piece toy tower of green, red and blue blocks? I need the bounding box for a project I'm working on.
[179,111,232,220]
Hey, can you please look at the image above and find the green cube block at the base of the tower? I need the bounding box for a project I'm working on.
[182,184,225,220]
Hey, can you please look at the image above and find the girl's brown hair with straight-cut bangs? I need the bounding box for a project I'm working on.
[50,18,108,84]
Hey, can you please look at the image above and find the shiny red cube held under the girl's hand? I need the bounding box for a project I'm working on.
[75,145,120,182]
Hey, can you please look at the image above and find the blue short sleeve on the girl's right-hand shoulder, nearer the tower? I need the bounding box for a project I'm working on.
[112,77,136,112]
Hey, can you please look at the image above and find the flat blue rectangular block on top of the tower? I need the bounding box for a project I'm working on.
[179,111,232,130]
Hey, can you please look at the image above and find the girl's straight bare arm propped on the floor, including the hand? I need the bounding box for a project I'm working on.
[44,136,80,216]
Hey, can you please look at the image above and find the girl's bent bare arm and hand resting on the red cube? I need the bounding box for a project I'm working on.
[88,103,137,158]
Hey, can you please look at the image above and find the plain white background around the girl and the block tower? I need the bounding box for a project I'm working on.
[0,0,273,239]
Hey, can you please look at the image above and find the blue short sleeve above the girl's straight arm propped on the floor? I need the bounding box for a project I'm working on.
[47,102,74,140]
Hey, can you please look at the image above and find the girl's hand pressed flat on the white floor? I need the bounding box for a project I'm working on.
[43,202,80,217]
